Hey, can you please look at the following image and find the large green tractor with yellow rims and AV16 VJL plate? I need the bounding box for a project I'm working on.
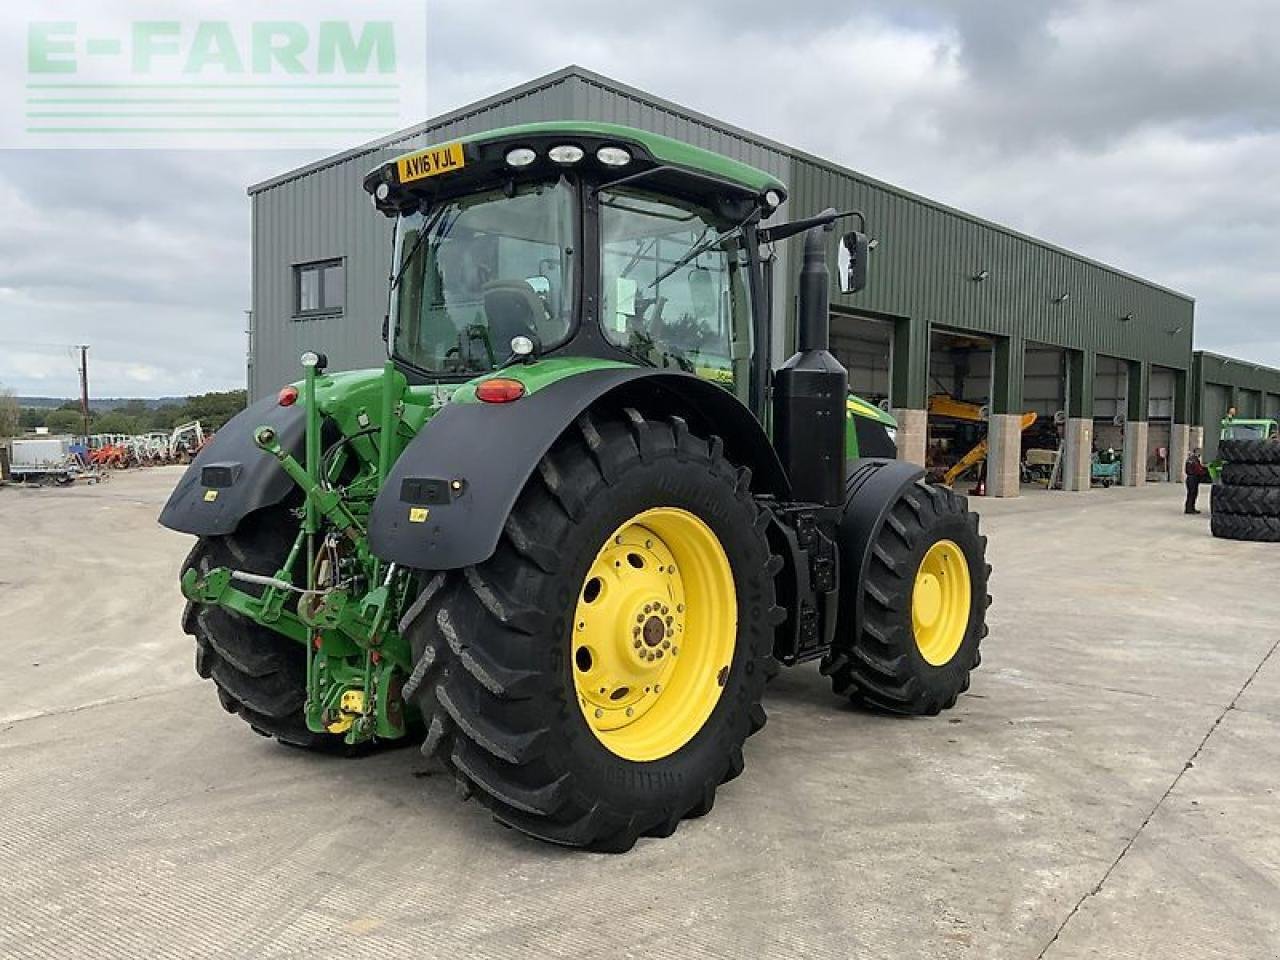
[160,122,989,851]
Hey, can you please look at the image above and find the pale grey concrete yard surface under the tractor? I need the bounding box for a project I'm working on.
[0,468,1280,960]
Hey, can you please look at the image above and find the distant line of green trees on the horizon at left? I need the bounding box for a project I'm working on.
[0,390,247,436]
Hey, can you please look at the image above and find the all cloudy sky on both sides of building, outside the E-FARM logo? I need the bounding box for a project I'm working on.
[0,0,1280,396]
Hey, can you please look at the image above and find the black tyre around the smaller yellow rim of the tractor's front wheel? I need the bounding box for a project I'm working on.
[822,480,991,716]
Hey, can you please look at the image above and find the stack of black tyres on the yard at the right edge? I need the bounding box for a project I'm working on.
[1210,440,1280,543]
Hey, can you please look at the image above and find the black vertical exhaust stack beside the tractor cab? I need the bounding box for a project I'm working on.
[773,210,849,507]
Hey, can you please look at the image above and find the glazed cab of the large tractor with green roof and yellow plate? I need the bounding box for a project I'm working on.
[365,123,860,416]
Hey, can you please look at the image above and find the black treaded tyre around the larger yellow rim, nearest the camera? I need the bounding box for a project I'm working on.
[401,410,782,852]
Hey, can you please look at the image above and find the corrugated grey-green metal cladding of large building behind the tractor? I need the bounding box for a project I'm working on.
[250,68,1194,397]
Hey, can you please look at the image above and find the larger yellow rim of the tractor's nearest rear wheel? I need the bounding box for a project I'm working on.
[572,507,737,762]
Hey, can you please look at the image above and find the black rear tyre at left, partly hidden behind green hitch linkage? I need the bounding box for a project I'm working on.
[182,508,347,753]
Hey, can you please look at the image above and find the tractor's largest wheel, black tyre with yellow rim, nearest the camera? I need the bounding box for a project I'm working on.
[402,410,782,851]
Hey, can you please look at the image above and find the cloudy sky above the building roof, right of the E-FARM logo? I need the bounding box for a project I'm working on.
[431,0,1280,366]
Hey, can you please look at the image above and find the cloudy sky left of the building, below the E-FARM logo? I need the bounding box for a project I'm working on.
[0,150,308,396]
